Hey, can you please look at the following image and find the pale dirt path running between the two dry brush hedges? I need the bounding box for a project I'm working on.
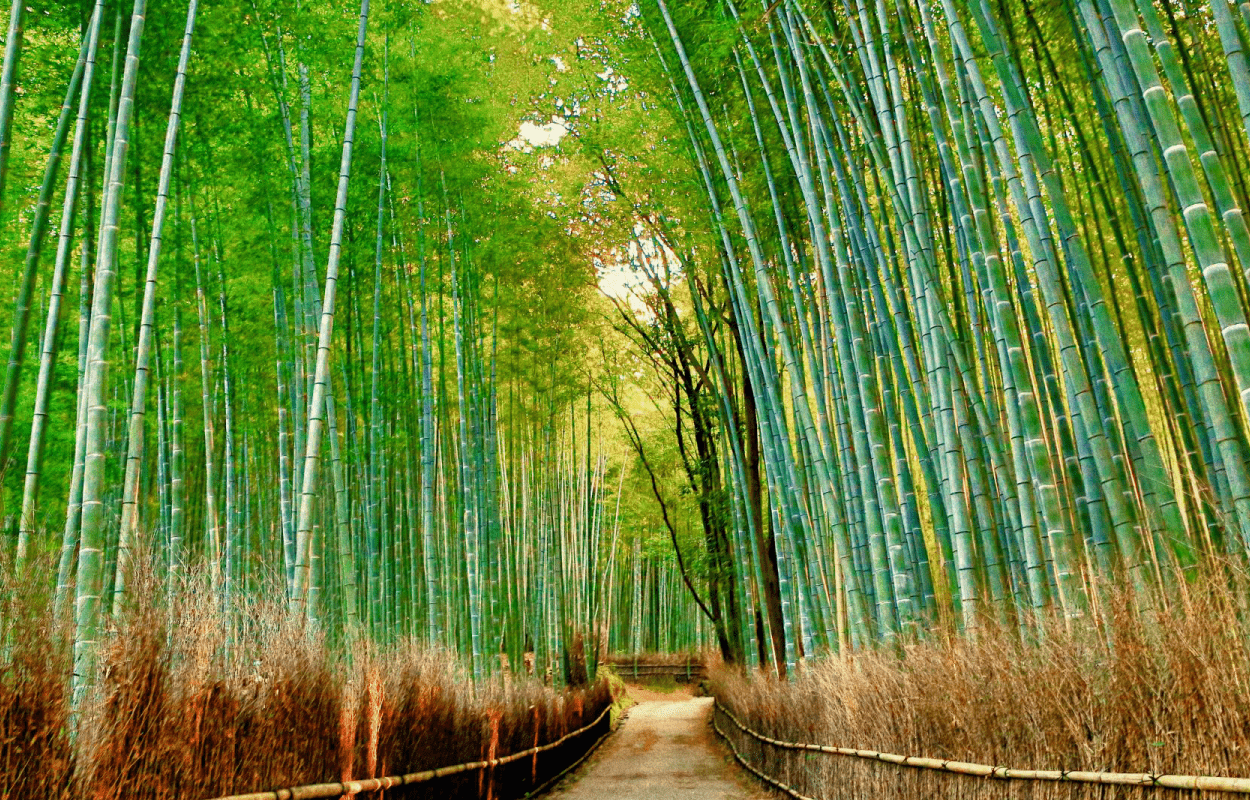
[551,693,766,800]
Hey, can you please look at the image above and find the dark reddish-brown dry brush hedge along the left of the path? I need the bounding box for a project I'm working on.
[0,555,610,800]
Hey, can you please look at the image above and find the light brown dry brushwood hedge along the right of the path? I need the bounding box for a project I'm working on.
[714,570,1250,800]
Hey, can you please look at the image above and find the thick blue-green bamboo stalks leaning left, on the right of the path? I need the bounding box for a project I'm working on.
[620,0,1250,669]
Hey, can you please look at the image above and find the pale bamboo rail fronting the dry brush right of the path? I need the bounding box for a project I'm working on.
[713,700,1250,800]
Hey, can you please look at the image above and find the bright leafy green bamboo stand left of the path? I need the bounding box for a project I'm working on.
[0,0,694,689]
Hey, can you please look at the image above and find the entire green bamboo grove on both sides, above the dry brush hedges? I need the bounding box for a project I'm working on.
[9,0,1250,705]
